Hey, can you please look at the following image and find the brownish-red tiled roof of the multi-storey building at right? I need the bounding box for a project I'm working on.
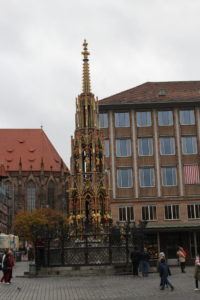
[99,81,200,105]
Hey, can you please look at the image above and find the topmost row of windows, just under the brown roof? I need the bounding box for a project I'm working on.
[99,110,195,128]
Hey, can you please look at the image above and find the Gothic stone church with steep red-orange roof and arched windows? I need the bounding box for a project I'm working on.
[0,129,69,233]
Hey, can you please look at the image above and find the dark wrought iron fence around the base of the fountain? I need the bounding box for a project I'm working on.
[36,221,148,268]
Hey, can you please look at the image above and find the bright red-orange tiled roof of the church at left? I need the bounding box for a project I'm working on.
[0,129,68,171]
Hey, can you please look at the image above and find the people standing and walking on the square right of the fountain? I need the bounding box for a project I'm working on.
[131,246,200,291]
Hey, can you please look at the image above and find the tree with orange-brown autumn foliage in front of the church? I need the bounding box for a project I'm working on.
[14,208,66,242]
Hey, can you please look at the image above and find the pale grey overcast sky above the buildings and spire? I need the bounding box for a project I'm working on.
[0,0,200,164]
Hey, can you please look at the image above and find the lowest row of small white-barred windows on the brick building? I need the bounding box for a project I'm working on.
[119,204,200,221]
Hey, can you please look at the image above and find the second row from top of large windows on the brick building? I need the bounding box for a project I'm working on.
[105,136,197,157]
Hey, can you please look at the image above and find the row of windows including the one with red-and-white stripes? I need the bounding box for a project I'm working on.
[117,164,200,188]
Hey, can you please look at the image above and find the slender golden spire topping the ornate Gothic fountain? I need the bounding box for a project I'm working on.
[82,40,90,94]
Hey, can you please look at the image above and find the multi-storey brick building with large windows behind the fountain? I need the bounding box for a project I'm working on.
[99,81,200,258]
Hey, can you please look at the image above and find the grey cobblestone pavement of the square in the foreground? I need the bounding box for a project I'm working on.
[0,263,200,300]
